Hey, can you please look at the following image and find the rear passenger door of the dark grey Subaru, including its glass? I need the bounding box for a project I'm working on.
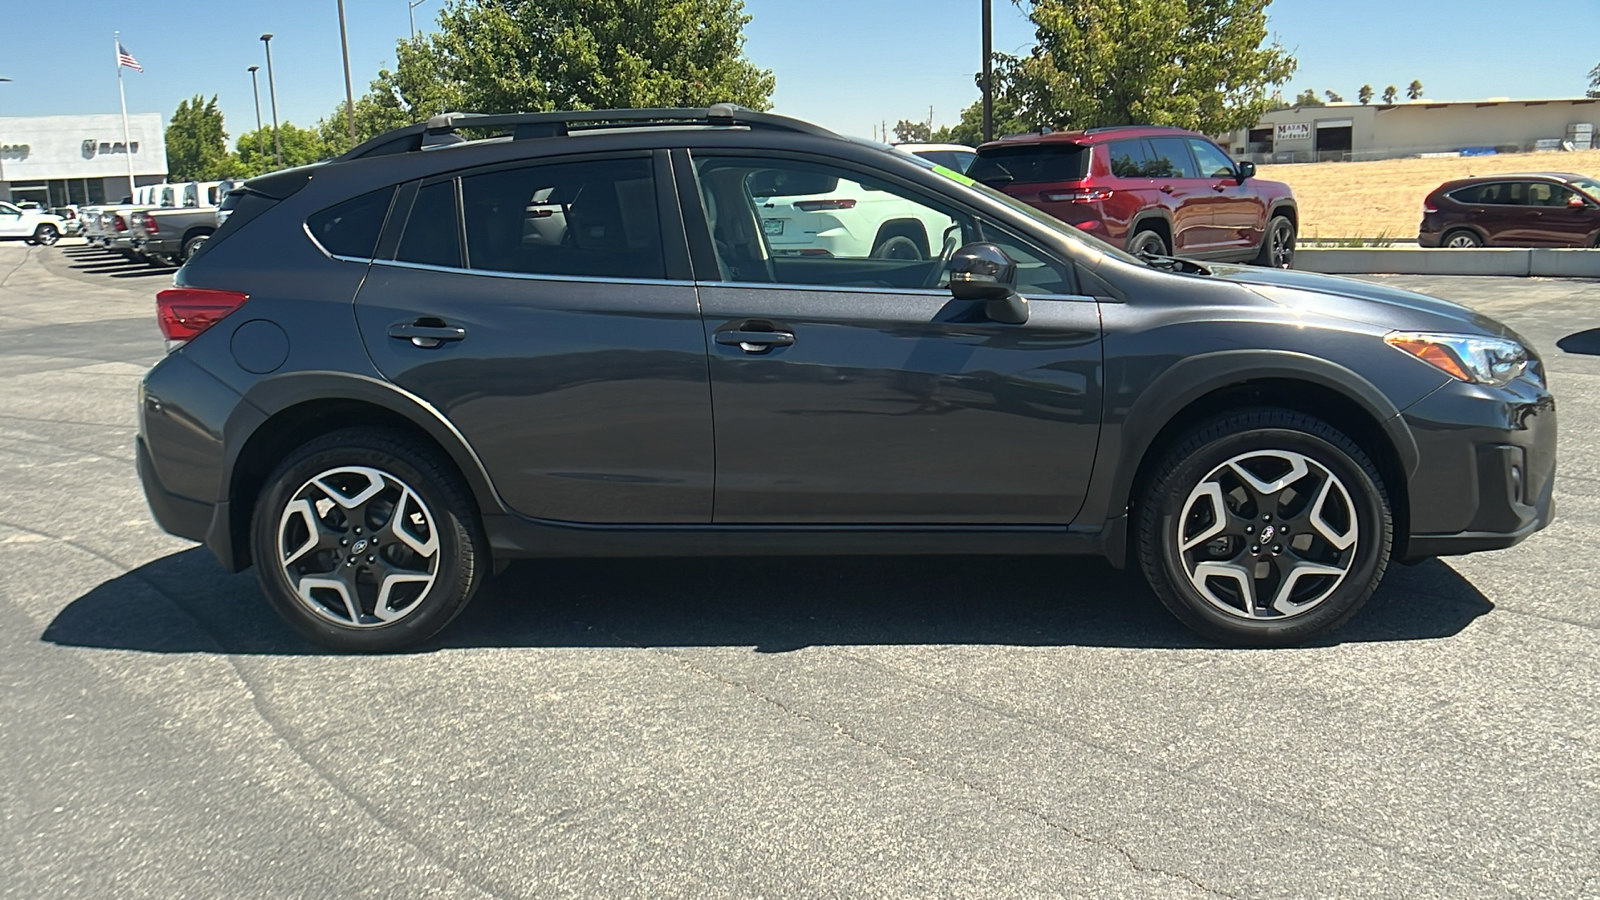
[363,151,714,524]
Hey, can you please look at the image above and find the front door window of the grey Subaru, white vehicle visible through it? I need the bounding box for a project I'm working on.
[694,157,978,288]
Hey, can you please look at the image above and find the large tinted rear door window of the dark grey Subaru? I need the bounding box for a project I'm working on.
[460,157,667,279]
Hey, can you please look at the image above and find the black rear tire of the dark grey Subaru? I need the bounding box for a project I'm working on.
[250,428,491,652]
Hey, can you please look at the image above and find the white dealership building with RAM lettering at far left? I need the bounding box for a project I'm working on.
[0,112,166,207]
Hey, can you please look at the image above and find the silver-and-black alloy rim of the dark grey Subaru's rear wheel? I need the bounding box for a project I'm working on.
[277,466,440,628]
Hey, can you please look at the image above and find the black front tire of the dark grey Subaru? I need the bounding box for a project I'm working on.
[1138,408,1394,647]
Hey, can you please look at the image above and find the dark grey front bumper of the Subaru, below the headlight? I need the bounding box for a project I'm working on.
[1402,364,1555,560]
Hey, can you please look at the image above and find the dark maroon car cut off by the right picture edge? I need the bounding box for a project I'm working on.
[1416,171,1600,248]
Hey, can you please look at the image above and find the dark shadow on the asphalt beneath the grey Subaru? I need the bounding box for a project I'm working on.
[43,548,1494,655]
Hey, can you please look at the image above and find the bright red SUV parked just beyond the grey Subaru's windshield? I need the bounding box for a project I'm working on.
[966,125,1299,267]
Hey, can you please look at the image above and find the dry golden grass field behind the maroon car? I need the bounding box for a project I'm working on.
[1259,151,1600,240]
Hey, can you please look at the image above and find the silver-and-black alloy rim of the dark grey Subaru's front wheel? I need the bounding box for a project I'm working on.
[1178,450,1360,621]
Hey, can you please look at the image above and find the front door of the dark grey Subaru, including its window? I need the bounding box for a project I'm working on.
[683,154,1101,525]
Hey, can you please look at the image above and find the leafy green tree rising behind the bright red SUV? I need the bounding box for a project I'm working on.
[995,0,1296,133]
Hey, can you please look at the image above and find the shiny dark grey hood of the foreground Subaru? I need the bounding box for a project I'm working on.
[1211,266,1525,343]
